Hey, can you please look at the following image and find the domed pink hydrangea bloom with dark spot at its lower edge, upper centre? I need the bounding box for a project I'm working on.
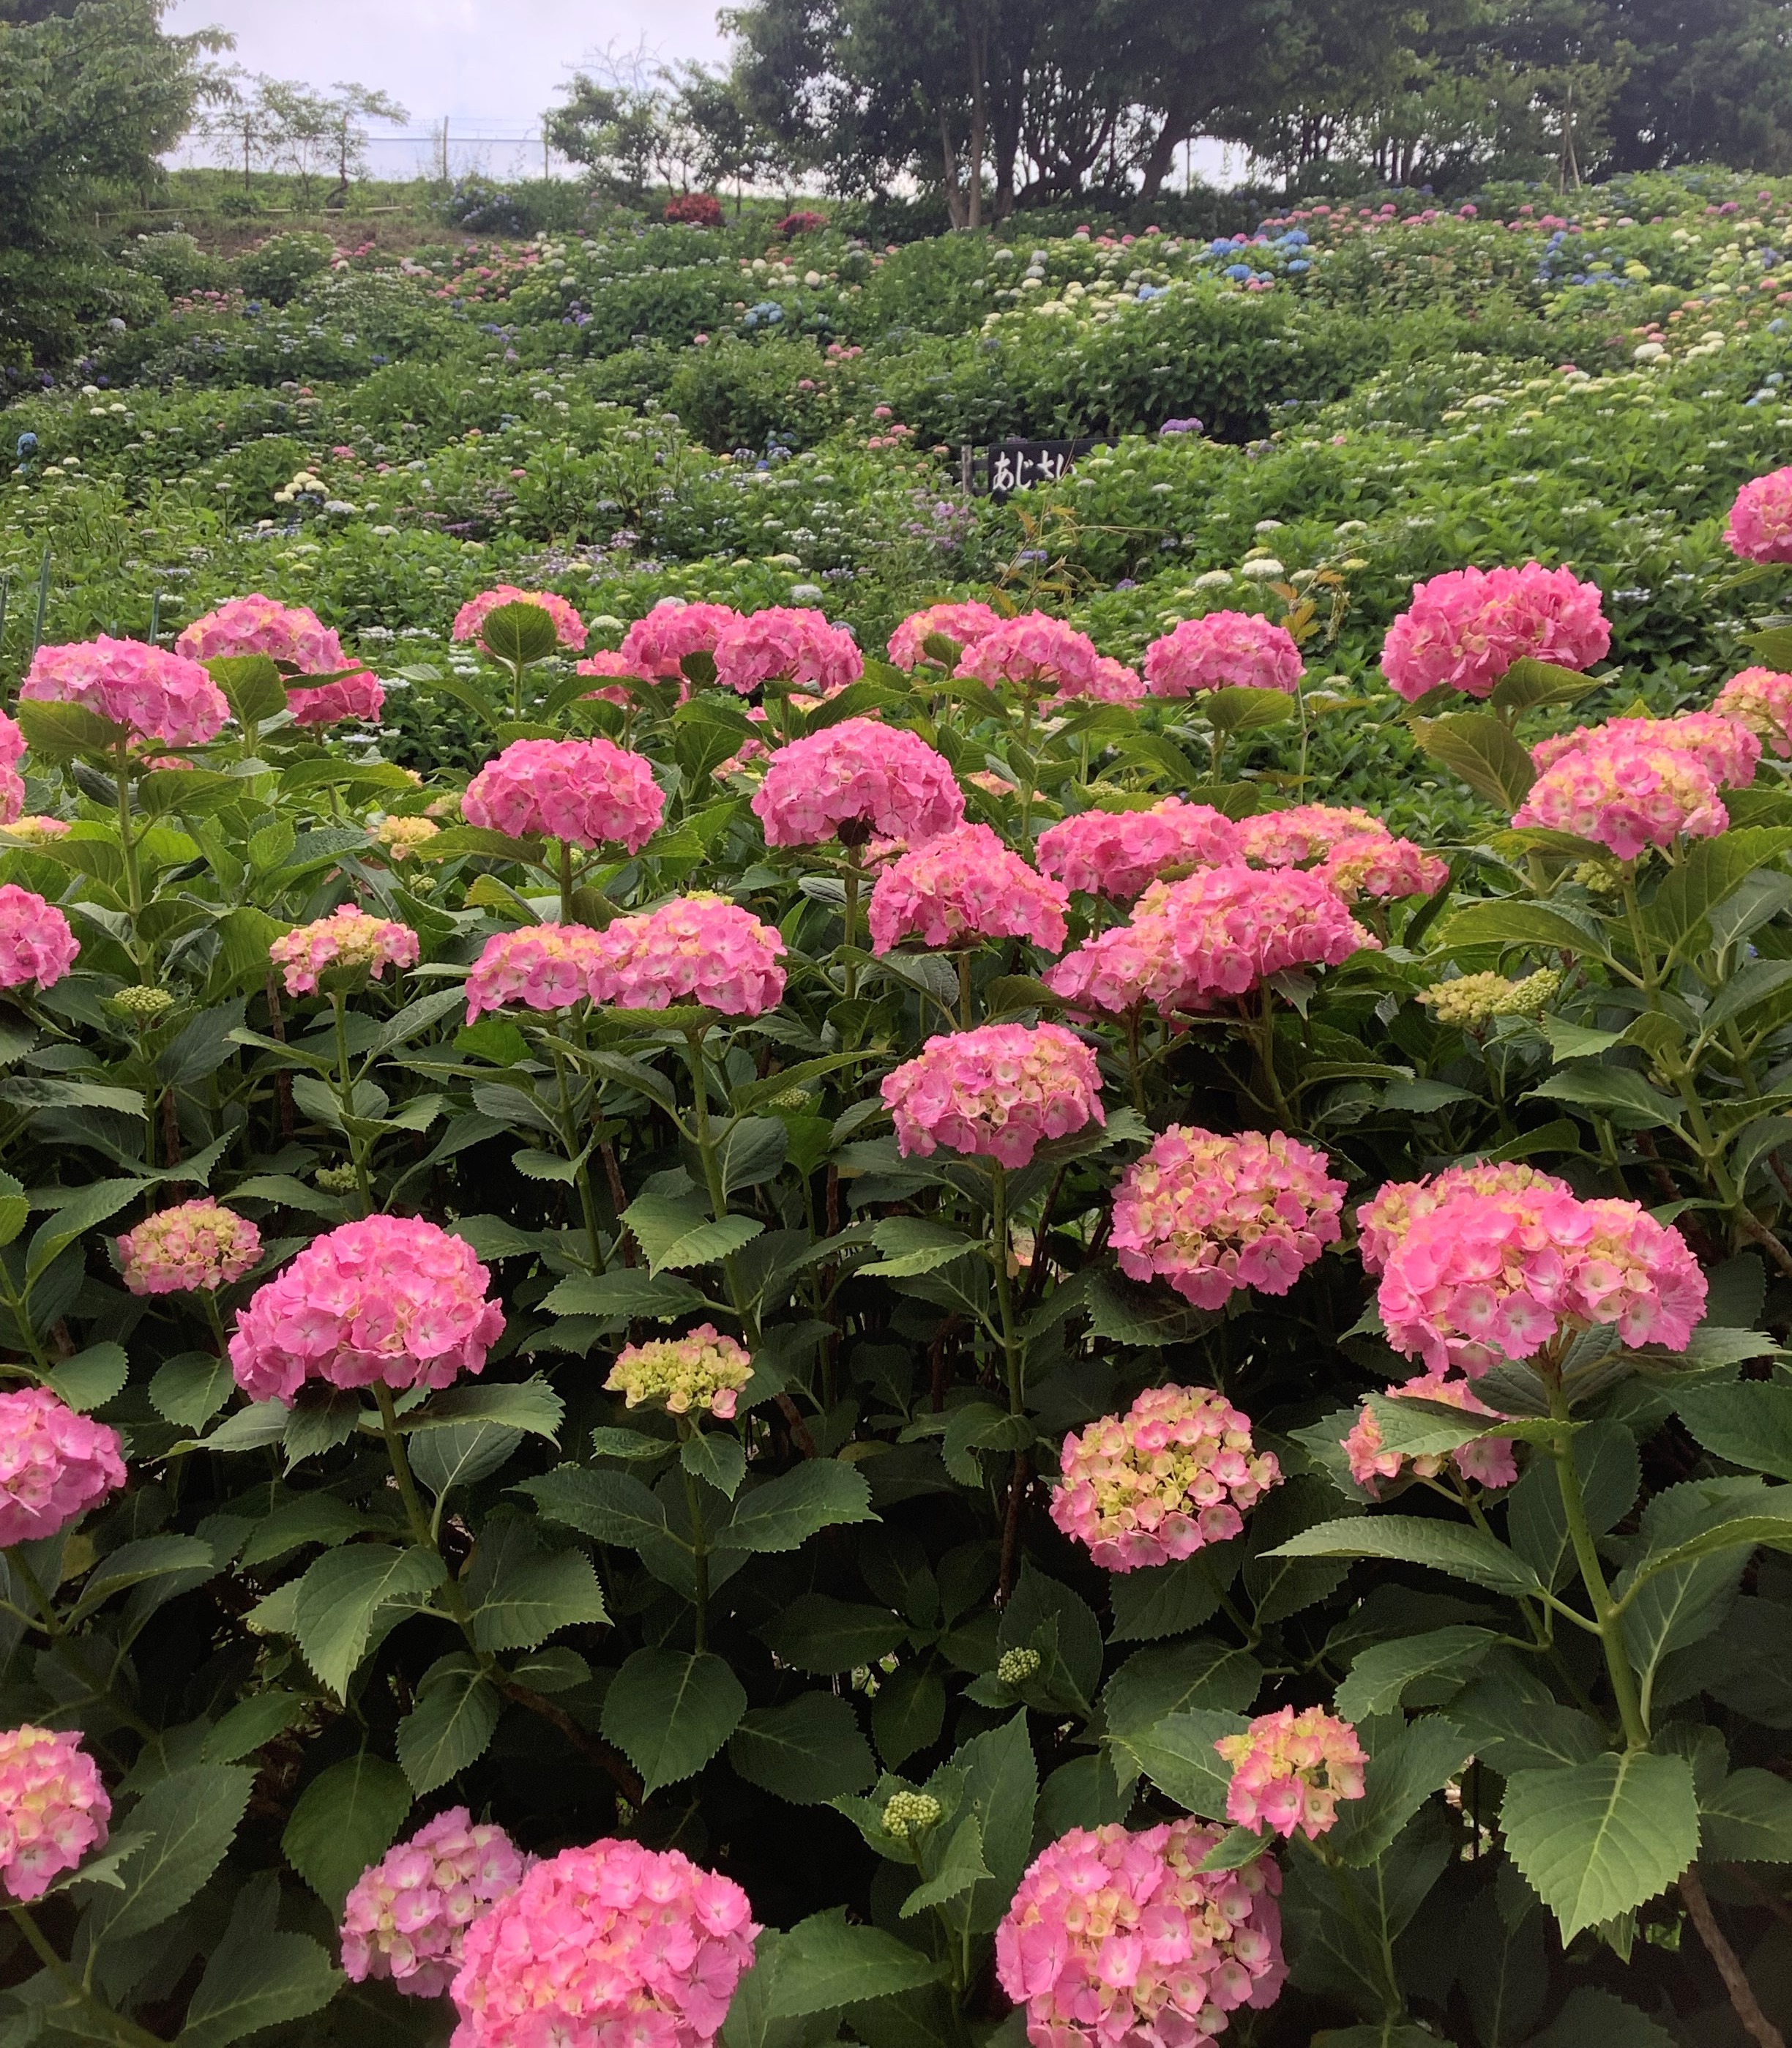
[752,719,965,846]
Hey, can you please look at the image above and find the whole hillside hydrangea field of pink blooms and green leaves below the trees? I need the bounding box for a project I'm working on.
[0,174,1792,2048]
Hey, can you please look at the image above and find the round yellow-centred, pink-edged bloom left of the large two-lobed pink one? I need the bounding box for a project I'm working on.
[1050,1387,1282,1571]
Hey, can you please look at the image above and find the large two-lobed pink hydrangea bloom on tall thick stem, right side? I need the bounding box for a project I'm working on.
[1376,1188,1706,1378]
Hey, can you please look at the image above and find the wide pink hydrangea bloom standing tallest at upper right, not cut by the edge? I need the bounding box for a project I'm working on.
[1381,561,1612,704]
